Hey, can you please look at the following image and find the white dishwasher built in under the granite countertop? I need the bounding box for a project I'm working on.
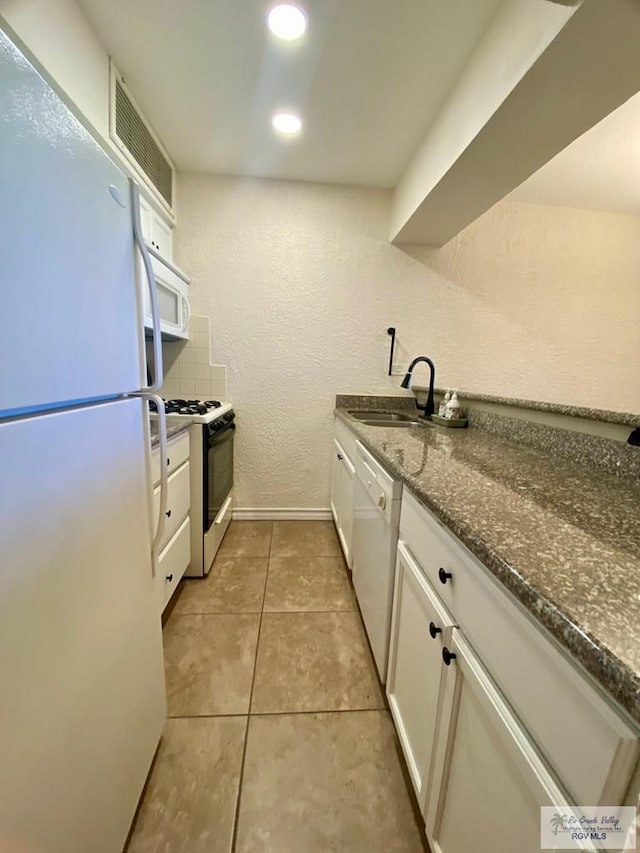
[352,441,402,683]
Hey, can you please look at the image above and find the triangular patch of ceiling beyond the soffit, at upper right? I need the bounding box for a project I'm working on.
[509,93,640,215]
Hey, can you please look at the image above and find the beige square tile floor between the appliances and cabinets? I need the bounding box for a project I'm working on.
[127,521,427,853]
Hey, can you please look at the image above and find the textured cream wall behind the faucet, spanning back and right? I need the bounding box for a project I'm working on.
[176,174,640,507]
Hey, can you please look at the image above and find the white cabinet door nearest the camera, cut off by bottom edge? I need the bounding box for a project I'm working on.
[426,629,589,853]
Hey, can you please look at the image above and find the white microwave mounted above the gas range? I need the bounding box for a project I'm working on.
[144,249,191,340]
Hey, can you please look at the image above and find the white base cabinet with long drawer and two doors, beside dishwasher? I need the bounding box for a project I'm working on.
[387,489,640,853]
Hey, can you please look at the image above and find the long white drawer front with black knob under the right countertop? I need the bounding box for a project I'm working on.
[400,489,638,803]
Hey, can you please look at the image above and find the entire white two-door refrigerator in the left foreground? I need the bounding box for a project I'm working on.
[0,30,166,853]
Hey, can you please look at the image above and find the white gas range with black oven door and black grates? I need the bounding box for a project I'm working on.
[151,400,236,578]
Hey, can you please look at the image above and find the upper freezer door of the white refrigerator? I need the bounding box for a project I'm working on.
[0,31,144,418]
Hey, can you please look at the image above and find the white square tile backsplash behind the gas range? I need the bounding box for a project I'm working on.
[149,316,227,400]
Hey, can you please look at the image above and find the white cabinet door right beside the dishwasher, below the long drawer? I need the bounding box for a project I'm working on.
[387,542,453,808]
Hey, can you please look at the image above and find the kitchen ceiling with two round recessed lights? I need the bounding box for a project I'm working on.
[77,0,502,188]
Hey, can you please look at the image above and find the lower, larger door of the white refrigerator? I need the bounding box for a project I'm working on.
[0,399,166,853]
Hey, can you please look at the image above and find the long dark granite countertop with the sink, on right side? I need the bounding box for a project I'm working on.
[335,398,640,723]
